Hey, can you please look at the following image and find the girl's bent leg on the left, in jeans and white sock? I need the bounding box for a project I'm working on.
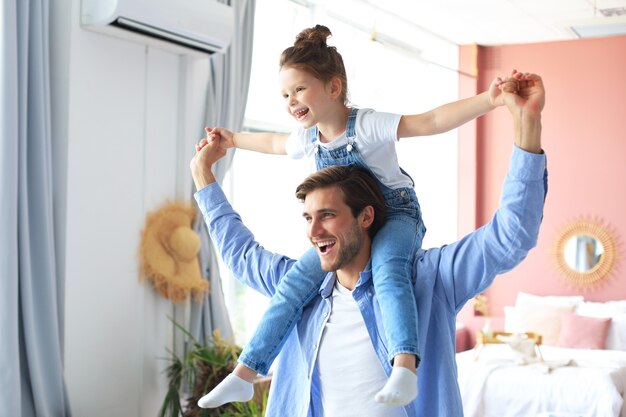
[198,248,326,408]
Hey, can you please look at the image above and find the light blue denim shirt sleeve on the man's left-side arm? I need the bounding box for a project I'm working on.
[194,183,295,297]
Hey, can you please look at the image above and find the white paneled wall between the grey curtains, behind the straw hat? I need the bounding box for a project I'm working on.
[51,0,208,417]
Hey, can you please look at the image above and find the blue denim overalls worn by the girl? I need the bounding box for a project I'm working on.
[239,109,426,375]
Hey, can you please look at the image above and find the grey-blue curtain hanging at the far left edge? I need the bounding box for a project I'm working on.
[0,0,70,417]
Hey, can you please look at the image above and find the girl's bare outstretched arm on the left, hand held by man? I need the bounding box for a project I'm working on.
[205,127,289,155]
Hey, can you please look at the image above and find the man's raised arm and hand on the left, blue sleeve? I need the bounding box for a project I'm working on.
[190,139,295,296]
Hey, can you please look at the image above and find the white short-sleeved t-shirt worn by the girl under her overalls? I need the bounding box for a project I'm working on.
[285,109,413,189]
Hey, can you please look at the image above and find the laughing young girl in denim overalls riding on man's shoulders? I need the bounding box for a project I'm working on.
[198,25,514,408]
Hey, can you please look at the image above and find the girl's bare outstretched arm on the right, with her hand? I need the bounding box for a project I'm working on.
[398,77,517,139]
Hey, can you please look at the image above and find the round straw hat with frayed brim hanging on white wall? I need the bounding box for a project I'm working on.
[140,203,209,302]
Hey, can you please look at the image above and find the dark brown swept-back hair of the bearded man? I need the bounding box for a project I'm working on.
[296,165,387,238]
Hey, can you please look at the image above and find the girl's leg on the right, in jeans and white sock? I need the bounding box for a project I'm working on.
[372,217,422,406]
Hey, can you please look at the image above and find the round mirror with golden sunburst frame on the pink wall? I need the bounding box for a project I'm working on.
[554,220,616,286]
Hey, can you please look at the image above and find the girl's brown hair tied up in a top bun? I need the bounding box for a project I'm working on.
[280,25,348,105]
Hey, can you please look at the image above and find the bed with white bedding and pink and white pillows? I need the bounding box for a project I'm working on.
[457,294,626,417]
